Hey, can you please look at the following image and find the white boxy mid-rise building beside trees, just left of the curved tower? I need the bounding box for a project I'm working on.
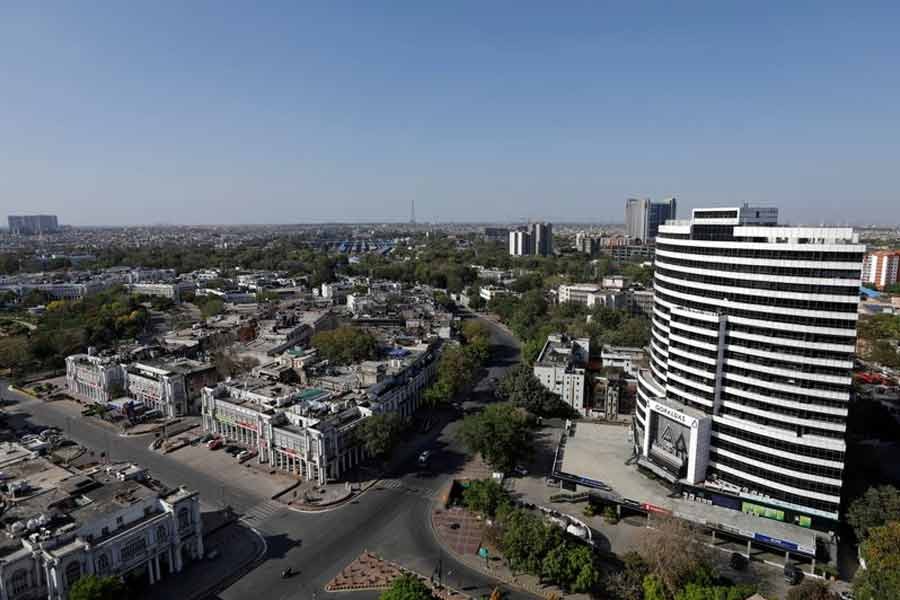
[534,334,591,414]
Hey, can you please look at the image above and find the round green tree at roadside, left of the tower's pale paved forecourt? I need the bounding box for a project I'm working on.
[459,403,531,472]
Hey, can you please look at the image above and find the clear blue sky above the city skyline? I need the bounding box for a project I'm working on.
[0,0,900,224]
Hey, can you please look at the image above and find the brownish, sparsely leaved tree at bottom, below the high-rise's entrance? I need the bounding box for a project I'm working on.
[641,518,712,596]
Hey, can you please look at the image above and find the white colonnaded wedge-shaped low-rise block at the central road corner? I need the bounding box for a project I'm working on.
[202,344,439,484]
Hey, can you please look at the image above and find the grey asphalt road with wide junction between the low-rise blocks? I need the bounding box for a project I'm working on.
[2,321,533,600]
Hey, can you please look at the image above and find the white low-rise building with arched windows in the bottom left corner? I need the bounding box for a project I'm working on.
[0,450,203,600]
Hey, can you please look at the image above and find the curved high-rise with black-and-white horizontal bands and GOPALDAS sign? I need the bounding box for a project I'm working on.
[633,206,865,526]
